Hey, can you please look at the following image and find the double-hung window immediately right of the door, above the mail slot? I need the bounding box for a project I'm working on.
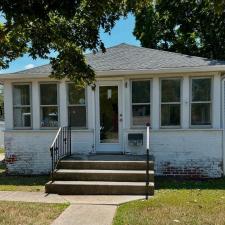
[131,80,151,126]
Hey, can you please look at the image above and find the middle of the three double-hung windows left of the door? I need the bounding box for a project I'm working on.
[40,83,59,128]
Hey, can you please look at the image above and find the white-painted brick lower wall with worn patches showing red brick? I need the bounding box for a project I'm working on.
[5,129,223,177]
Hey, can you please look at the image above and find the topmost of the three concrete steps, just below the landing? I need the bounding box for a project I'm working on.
[58,160,154,170]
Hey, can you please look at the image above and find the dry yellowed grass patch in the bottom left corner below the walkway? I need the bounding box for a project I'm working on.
[0,201,68,225]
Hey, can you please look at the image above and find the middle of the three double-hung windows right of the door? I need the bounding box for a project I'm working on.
[161,78,181,127]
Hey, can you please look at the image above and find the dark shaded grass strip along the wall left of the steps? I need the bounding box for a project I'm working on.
[0,163,50,190]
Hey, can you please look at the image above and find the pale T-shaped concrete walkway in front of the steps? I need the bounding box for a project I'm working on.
[0,191,144,225]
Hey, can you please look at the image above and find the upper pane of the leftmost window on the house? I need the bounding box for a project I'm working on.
[13,84,30,105]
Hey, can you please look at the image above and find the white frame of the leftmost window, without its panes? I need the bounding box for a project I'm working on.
[12,82,33,130]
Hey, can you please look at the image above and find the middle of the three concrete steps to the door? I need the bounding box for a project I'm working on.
[53,169,154,182]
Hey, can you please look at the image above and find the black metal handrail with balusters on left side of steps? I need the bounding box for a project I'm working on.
[50,127,71,178]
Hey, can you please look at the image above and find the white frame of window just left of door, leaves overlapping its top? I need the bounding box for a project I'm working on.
[66,82,88,130]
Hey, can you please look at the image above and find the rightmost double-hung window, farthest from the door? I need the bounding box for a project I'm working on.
[191,77,212,126]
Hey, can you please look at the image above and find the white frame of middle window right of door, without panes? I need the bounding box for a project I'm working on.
[159,77,183,129]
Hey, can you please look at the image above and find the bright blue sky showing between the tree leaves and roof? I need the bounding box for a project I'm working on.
[0,15,140,73]
